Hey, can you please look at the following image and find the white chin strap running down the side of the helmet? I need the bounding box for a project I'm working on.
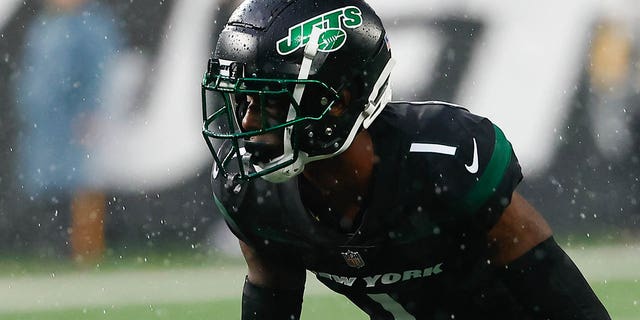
[256,28,322,183]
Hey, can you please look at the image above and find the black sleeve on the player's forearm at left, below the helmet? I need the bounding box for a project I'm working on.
[242,279,303,320]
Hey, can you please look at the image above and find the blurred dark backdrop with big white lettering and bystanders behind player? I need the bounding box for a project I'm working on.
[0,0,640,260]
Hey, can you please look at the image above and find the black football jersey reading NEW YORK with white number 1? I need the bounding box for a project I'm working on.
[212,102,523,319]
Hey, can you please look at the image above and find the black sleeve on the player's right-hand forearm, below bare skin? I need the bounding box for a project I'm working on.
[502,237,610,320]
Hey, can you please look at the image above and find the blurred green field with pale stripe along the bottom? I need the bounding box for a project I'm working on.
[0,242,640,320]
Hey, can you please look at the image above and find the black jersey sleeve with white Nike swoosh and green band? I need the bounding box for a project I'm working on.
[410,107,522,229]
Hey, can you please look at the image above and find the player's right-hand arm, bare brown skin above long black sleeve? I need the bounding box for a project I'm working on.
[488,192,610,319]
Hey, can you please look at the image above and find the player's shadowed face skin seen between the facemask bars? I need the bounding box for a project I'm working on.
[241,94,289,163]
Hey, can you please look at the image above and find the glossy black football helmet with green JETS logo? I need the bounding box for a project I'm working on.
[202,0,393,182]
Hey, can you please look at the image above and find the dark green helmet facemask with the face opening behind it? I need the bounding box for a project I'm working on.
[202,59,340,181]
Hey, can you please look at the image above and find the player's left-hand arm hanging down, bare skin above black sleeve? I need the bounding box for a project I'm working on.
[240,241,306,320]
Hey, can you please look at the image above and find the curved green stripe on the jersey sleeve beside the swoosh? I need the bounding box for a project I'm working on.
[462,125,511,213]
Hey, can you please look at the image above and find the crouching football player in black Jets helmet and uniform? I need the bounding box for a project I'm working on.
[202,0,609,320]
